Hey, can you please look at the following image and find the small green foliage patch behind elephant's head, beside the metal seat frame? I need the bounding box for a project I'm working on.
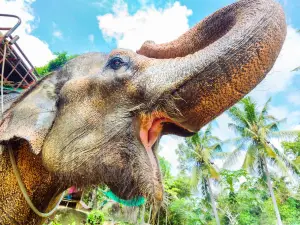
[35,52,77,76]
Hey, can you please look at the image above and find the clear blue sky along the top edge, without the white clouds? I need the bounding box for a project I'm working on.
[25,0,300,54]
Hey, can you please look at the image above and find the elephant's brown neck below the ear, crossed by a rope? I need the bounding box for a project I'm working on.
[0,143,60,224]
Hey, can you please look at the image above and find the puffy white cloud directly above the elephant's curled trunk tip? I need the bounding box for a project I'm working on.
[97,0,192,50]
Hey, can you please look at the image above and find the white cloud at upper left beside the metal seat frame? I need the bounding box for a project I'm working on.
[0,0,54,66]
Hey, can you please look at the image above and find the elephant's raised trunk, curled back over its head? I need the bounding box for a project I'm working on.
[137,0,286,131]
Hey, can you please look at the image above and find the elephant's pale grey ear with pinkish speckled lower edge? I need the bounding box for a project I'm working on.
[0,74,57,154]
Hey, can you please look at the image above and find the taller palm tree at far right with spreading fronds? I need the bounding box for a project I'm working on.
[224,97,299,225]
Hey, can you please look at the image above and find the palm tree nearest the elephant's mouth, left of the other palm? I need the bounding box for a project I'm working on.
[176,124,221,225]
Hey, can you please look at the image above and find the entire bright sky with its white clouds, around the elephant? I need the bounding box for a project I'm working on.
[0,0,300,174]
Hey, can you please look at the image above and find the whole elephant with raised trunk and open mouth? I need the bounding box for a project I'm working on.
[0,0,286,224]
